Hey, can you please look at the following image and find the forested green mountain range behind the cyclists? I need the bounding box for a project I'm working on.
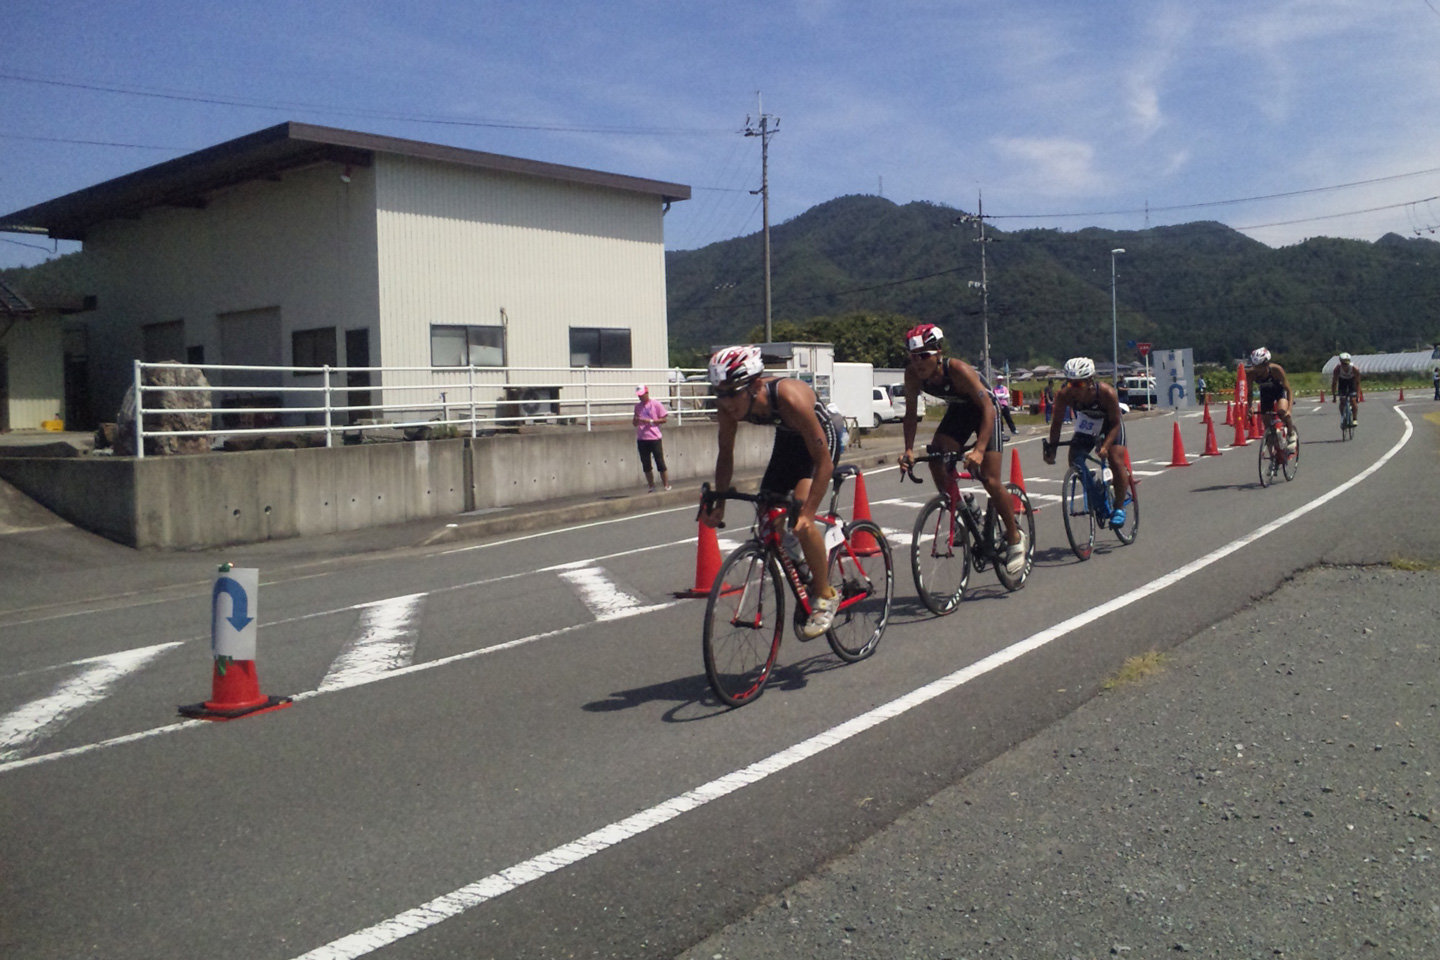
[665,196,1440,370]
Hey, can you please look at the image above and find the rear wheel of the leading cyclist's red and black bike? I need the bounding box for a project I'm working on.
[825,520,896,664]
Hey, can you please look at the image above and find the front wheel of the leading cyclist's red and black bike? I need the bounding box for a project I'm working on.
[704,543,785,707]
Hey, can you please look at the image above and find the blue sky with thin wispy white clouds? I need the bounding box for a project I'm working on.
[0,0,1440,266]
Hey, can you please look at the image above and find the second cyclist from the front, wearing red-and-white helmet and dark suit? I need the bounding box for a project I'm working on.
[900,324,1025,577]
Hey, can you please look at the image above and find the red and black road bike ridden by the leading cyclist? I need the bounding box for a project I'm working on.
[701,463,894,707]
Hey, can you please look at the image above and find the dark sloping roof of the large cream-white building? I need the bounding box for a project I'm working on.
[0,122,690,240]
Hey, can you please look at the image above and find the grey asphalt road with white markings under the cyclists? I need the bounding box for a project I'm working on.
[0,399,1440,959]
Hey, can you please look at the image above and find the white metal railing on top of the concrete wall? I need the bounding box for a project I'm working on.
[132,360,714,456]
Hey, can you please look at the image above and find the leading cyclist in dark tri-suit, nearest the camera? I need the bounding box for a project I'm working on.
[701,344,840,639]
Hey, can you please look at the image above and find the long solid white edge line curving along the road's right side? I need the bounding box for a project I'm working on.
[297,410,1414,960]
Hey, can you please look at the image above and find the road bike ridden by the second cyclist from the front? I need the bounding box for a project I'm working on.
[901,448,1035,616]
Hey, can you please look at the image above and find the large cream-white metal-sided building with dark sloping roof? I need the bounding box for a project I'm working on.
[0,122,690,420]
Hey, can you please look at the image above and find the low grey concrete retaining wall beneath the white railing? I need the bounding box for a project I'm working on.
[0,423,775,550]
